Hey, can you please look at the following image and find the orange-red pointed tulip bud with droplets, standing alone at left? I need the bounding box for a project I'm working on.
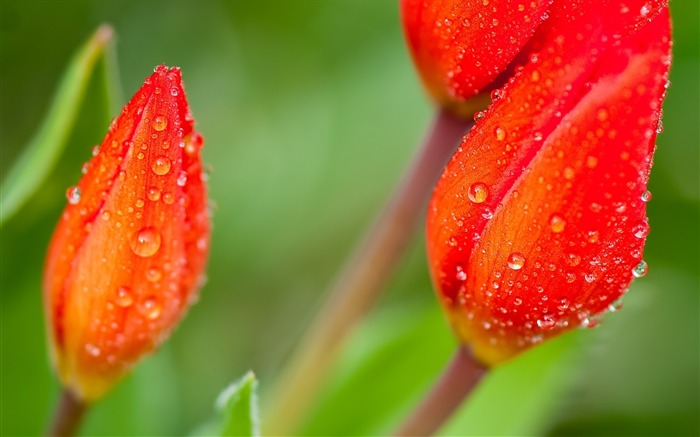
[44,65,210,401]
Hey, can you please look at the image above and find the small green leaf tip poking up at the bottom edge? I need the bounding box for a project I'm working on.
[216,372,260,437]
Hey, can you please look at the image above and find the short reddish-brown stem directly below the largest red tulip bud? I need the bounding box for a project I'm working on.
[394,345,487,436]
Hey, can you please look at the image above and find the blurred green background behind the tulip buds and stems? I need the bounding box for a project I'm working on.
[0,0,700,436]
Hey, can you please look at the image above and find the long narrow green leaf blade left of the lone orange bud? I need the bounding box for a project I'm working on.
[0,25,113,226]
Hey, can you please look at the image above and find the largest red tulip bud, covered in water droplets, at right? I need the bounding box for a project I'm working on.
[427,0,671,364]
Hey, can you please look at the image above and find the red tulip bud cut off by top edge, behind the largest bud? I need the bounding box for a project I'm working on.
[401,0,552,114]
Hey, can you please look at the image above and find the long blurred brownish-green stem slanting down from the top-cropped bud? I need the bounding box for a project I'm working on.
[265,110,470,435]
